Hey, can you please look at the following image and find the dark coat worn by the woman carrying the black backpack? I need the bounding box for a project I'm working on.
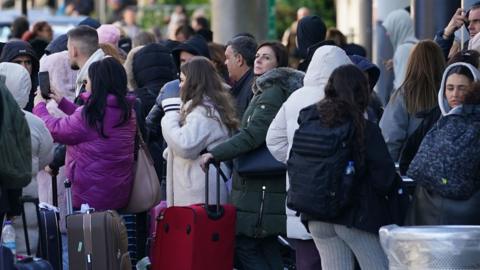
[298,104,396,234]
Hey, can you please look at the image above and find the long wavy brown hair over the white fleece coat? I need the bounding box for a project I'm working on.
[180,56,239,131]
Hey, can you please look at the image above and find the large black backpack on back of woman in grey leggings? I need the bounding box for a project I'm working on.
[287,105,354,220]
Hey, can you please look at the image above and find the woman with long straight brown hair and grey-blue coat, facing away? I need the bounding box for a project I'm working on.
[380,40,445,167]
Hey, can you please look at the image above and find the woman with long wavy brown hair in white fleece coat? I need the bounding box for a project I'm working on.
[162,56,239,206]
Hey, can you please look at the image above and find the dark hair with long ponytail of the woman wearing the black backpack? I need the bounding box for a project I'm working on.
[317,65,370,166]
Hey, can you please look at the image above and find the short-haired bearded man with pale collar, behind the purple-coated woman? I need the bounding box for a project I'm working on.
[67,25,105,97]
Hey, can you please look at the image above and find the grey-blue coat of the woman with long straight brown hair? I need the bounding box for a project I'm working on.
[380,88,422,162]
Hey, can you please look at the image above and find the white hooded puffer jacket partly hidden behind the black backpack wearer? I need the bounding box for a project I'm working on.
[266,46,352,239]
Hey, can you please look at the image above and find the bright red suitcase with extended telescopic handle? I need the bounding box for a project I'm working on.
[152,162,236,270]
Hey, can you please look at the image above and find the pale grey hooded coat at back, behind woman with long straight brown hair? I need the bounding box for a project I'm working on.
[383,9,418,89]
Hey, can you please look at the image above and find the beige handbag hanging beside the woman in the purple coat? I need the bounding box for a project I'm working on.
[121,128,161,214]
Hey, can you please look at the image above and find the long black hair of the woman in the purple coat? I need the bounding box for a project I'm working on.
[82,57,131,138]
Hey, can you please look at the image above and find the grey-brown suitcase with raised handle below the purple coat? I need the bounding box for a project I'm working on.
[65,179,132,270]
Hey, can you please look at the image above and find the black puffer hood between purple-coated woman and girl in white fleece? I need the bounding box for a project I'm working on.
[132,43,177,90]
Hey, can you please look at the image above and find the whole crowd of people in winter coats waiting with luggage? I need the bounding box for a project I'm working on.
[0,2,480,270]
